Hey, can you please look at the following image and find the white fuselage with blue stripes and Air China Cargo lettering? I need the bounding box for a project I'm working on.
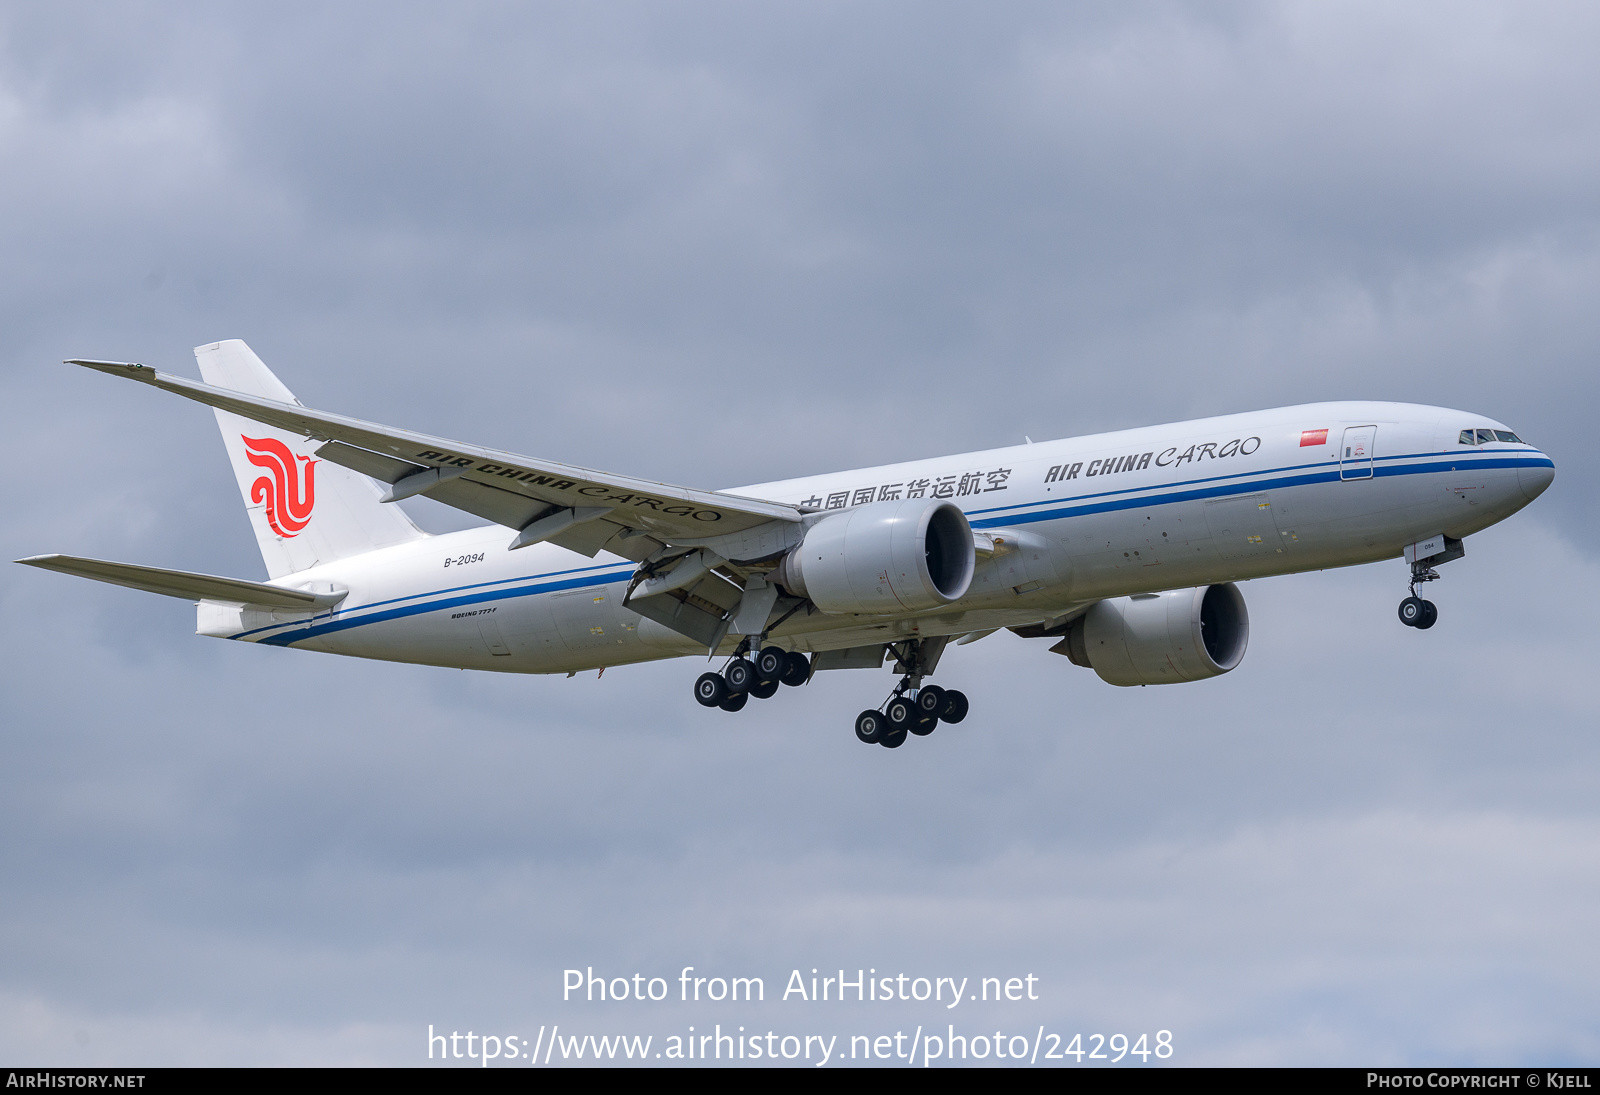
[198,402,1554,672]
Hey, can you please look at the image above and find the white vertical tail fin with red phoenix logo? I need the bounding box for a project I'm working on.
[195,338,427,578]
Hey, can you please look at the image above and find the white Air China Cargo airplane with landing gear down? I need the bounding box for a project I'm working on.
[19,339,1555,748]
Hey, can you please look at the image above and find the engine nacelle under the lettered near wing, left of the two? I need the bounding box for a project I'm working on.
[773,498,978,615]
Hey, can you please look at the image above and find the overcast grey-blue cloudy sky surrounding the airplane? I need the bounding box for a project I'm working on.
[0,3,1600,1065]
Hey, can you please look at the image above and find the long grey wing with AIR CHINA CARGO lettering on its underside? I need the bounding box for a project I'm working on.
[67,359,803,559]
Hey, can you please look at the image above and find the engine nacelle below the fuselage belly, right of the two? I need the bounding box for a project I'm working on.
[1053,583,1250,687]
